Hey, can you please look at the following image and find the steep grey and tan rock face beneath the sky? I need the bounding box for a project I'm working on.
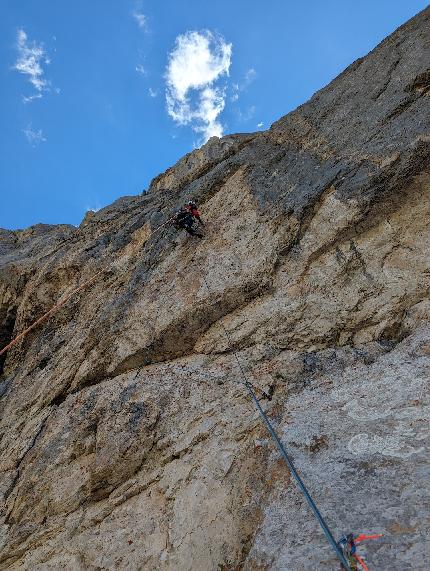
[0,9,430,571]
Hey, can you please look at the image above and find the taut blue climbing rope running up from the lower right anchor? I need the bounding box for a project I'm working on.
[198,274,352,571]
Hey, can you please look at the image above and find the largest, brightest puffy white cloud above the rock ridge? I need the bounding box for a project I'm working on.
[166,30,232,142]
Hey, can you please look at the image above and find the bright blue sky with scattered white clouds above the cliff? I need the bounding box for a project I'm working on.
[0,0,427,229]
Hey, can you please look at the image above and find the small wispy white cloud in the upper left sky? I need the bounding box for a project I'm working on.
[14,29,51,103]
